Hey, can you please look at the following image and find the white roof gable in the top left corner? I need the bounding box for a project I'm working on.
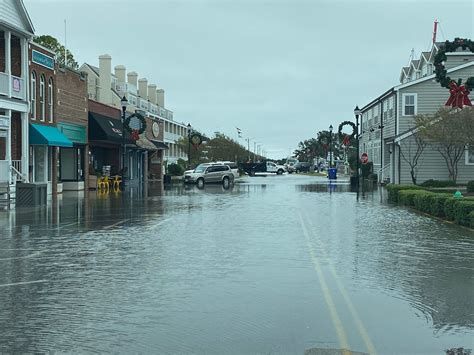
[0,0,35,37]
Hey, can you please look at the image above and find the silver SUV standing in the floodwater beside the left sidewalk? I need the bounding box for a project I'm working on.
[184,164,234,188]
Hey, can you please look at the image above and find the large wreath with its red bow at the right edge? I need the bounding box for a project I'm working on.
[434,38,474,108]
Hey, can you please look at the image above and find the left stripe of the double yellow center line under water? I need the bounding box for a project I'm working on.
[298,213,349,355]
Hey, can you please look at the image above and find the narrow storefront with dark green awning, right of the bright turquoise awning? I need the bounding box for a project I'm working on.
[57,123,88,191]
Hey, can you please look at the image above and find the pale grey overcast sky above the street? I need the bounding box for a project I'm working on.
[24,0,474,158]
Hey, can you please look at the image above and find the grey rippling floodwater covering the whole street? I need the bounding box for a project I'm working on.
[0,175,474,354]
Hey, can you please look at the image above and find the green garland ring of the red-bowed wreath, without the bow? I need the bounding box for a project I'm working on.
[434,38,474,91]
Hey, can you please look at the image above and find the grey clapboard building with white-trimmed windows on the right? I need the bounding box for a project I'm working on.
[360,43,474,184]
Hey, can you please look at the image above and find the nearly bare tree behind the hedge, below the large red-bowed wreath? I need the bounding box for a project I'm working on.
[416,107,474,182]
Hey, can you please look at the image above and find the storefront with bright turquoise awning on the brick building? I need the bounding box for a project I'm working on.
[29,124,73,194]
